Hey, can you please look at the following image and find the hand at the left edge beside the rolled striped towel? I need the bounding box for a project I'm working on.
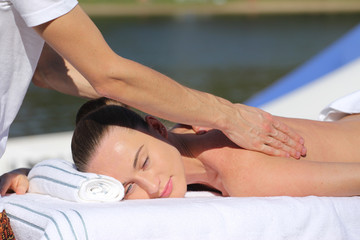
[0,168,30,196]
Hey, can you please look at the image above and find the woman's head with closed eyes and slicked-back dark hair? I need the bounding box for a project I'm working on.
[71,103,186,199]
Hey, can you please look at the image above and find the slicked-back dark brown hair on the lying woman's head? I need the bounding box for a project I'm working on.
[71,104,149,171]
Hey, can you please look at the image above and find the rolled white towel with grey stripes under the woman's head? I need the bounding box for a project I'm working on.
[28,159,124,202]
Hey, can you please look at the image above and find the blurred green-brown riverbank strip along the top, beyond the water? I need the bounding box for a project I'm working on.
[80,0,360,16]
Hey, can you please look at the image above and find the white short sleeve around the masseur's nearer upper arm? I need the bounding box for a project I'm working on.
[10,0,78,27]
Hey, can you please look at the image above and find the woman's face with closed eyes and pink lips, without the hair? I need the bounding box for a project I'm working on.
[88,124,186,199]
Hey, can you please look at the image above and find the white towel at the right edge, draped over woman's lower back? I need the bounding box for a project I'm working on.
[319,91,360,121]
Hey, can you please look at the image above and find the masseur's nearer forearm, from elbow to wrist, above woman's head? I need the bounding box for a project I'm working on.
[98,58,235,129]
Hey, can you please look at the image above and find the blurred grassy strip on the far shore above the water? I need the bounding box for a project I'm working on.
[79,0,360,16]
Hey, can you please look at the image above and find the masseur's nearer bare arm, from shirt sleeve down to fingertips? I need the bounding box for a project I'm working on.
[35,6,303,157]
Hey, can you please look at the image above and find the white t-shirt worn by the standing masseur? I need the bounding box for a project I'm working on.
[0,0,78,157]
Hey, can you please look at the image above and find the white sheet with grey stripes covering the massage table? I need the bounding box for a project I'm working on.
[1,194,360,240]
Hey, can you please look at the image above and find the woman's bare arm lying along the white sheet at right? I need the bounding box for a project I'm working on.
[221,151,360,197]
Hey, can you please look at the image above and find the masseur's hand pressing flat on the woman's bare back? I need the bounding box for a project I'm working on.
[224,104,306,159]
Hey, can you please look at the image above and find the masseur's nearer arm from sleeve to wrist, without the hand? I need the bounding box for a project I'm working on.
[36,8,235,129]
